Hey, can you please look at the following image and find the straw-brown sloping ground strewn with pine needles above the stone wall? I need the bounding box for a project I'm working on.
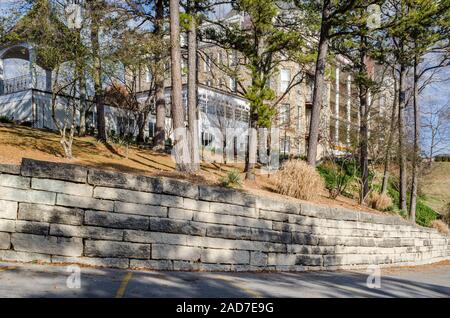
[0,124,383,214]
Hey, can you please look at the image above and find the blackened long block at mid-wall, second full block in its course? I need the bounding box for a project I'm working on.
[84,211,149,230]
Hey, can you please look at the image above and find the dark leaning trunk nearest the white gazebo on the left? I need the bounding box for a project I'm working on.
[90,3,107,142]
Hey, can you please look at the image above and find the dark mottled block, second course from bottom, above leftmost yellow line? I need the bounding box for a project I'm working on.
[84,240,151,259]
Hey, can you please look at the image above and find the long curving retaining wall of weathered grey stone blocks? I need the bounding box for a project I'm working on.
[0,159,450,271]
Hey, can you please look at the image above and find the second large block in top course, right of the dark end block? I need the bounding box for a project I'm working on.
[88,169,162,193]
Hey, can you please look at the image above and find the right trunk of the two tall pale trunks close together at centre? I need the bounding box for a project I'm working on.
[188,1,200,172]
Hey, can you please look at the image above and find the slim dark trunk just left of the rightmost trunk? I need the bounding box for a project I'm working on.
[398,64,407,211]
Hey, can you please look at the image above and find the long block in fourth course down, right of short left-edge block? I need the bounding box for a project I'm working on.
[18,203,84,225]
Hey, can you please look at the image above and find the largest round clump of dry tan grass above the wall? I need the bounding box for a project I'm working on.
[273,160,324,200]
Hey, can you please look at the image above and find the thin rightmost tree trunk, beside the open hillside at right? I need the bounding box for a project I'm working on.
[409,52,420,222]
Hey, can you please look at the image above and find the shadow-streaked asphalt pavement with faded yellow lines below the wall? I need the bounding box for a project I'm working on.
[0,262,450,298]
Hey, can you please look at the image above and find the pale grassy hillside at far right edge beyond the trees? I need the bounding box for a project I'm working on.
[421,162,450,212]
